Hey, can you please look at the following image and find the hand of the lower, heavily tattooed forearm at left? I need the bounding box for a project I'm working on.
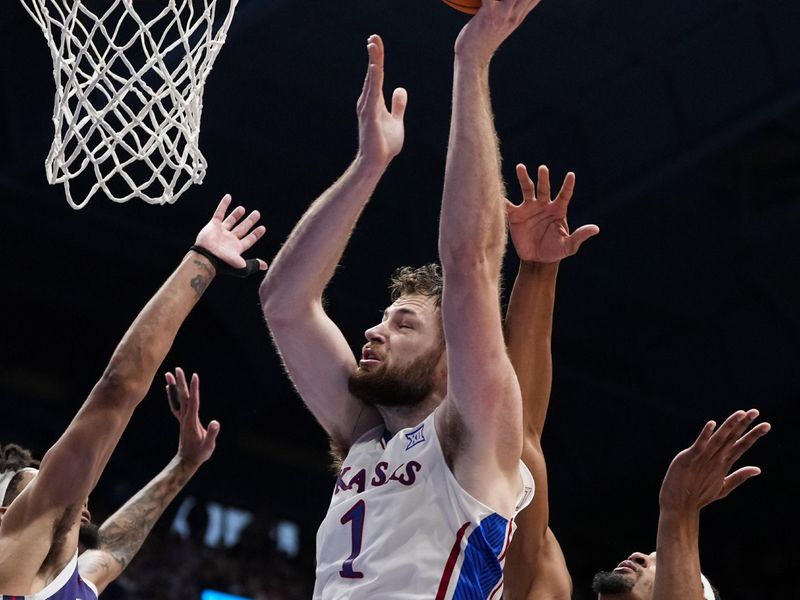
[165,367,219,467]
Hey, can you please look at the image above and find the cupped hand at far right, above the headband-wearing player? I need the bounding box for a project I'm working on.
[659,409,770,511]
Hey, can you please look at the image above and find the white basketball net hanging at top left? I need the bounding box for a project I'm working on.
[21,0,238,208]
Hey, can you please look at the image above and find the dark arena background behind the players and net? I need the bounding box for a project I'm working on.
[0,0,800,600]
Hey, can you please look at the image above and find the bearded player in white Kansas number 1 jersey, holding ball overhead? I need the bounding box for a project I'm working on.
[261,0,556,600]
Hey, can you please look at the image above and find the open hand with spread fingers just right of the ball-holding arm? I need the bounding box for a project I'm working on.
[506,164,600,263]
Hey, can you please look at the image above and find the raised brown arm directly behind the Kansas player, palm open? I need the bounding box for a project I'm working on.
[504,164,599,600]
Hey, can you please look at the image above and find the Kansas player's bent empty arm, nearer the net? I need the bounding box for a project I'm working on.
[261,35,406,448]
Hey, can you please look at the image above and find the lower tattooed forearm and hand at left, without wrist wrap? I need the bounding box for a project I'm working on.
[78,368,219,593]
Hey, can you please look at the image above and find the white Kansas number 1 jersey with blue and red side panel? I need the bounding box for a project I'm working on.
[314,411,534,600]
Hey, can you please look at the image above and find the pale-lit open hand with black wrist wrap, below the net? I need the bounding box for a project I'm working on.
[195,194,267,271]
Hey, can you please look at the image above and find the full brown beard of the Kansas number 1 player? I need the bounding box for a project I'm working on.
[347,347,444,408]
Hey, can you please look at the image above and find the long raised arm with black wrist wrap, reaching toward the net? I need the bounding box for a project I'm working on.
[0,196,266,595]
